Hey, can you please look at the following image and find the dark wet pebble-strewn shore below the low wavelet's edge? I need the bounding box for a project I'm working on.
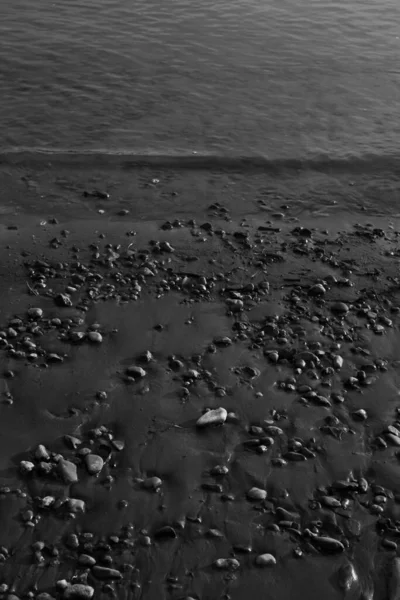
[0,162,400,600]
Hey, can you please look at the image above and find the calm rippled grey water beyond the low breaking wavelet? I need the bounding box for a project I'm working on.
[0,0,400,158]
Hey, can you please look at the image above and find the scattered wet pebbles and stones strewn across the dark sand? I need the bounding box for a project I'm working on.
[0,213,400,600]
